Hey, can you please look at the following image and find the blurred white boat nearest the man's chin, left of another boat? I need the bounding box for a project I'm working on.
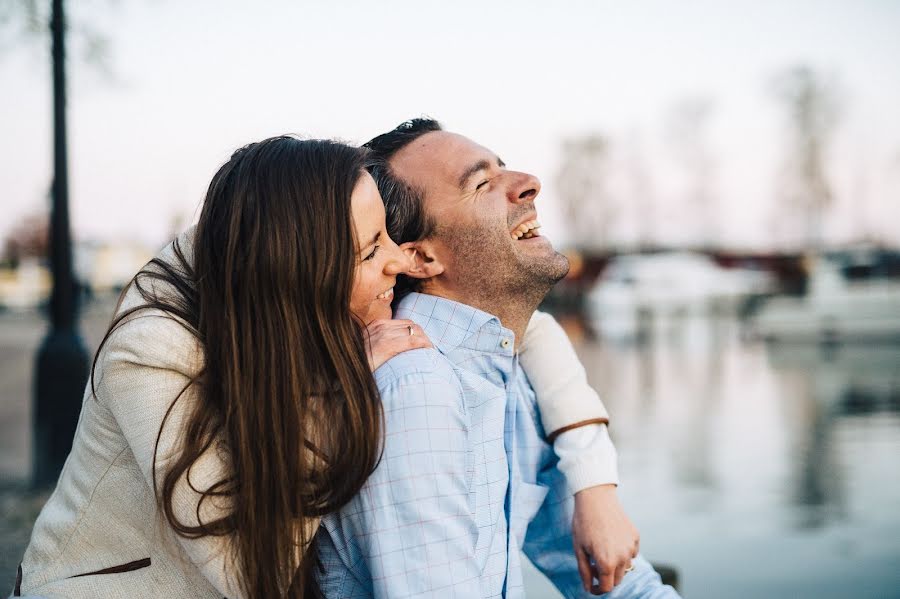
[586,252,773,340]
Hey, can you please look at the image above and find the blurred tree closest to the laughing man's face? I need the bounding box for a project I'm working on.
[556,133,619,251]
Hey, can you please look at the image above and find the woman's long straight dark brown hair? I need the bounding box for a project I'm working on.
[94,137,382,597]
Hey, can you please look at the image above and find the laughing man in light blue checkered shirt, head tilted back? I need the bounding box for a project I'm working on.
[318,119,677,599]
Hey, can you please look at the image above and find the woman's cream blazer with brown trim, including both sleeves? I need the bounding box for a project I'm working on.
[17,230,606,599]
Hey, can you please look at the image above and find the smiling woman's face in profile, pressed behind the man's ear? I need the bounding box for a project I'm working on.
[350,173,409,324]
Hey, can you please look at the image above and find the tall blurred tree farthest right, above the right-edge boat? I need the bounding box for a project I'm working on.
[772,66,841,250]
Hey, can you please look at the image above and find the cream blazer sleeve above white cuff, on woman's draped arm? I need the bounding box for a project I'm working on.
[519,312,609,442]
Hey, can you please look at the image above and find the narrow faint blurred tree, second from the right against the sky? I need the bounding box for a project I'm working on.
[666,96,719,246]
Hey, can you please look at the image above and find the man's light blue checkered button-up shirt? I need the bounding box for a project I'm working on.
[317,293,677,599]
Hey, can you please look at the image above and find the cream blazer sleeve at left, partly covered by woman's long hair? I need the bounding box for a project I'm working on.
[95,310,243,599]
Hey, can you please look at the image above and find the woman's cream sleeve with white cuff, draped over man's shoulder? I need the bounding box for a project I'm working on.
[519,312,619,493]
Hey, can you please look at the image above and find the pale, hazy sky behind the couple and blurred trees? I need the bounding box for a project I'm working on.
[0,0,900,248]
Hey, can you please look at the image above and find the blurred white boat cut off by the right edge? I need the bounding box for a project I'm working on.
[750,257,900,342]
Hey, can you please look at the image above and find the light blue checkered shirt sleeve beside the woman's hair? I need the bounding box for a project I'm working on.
[318,358,481,599]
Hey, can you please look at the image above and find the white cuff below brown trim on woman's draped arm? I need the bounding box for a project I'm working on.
[553,424,619,495]
